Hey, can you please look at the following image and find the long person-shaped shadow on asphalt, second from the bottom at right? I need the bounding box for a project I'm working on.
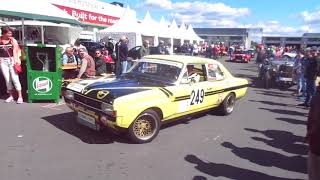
[221,142,307,174]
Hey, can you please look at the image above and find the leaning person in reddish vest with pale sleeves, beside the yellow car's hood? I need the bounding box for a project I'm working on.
[77,48,96,78]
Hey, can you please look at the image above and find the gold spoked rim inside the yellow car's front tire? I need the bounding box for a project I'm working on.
[133,116,155,140]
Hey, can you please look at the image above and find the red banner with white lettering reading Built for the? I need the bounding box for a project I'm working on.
[54,4,119,26]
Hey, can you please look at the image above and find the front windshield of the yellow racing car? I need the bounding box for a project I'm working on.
[127,60,183,83]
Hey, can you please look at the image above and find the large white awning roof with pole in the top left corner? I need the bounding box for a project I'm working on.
[0,0,79,44]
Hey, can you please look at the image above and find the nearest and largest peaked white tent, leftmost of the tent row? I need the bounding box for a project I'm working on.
[97,7,142,48]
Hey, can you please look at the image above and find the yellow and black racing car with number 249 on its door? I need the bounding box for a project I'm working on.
[63,55,248,143]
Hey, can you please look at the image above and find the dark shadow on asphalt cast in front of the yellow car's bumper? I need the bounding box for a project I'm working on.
[42,112,130,144]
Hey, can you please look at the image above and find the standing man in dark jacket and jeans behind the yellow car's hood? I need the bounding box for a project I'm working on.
[116,36,129,76]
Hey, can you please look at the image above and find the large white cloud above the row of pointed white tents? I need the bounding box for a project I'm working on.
[140,0,250,27]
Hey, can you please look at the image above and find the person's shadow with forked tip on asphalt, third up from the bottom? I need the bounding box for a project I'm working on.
[245,128,308,155]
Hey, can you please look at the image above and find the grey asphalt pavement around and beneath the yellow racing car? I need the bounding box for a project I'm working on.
[0,56,308,180]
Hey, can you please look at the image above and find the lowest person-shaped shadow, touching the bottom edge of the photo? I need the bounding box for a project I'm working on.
[185,155,302,180]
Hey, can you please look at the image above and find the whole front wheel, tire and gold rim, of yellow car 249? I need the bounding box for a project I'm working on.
[128,110,160,144]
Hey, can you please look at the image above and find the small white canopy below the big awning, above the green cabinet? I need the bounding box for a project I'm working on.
[6,20,82,45]
